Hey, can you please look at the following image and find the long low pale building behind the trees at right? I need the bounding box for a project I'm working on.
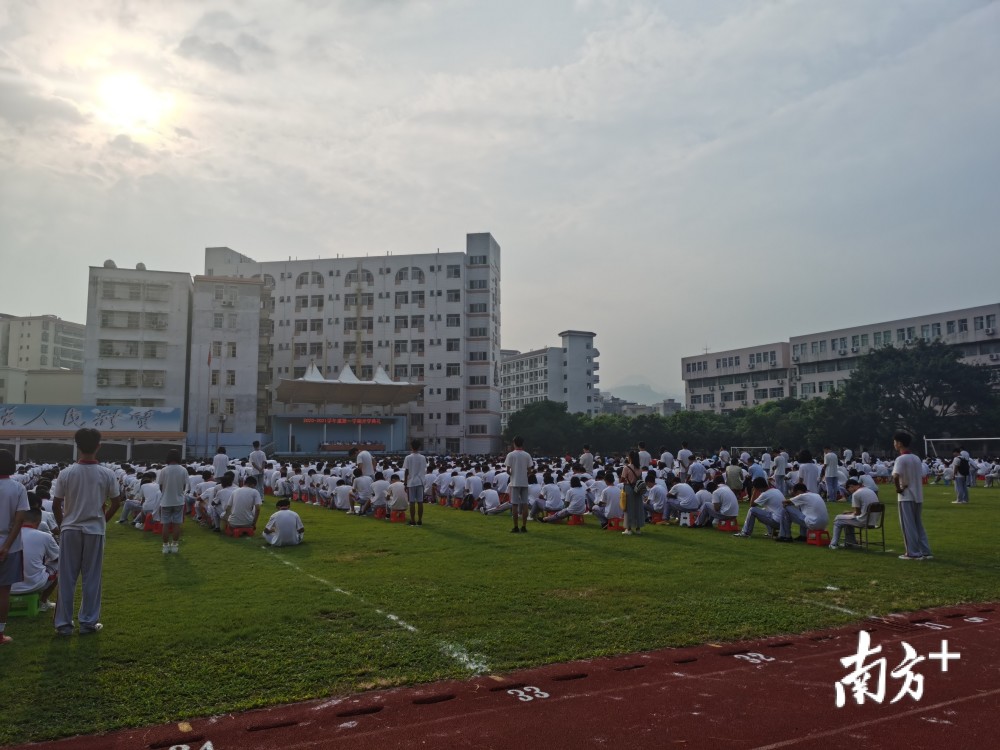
[681,304,1000,412]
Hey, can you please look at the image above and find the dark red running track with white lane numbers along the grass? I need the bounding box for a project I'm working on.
[9,604,1000,750]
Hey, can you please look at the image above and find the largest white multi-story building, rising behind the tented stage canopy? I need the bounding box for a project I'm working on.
[205,233,501,453]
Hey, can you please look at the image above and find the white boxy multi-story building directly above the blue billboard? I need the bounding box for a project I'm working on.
[83,261,191,418]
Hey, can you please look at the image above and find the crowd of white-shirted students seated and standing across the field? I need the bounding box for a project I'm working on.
[0,431,1000,643]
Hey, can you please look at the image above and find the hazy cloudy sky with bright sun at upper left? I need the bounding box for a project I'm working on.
[0,0,1000,396]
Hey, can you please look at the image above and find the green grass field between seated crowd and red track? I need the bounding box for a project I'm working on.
[0,487,1000,745]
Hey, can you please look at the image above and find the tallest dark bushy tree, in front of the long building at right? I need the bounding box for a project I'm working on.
[828,340,997,452]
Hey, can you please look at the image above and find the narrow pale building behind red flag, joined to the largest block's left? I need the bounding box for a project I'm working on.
[187,276,272,456]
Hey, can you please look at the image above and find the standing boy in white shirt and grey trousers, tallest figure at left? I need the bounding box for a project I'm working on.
[52,427,122,635]
